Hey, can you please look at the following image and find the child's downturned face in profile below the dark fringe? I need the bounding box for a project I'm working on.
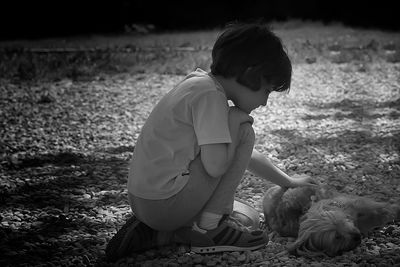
[234,81,273,114]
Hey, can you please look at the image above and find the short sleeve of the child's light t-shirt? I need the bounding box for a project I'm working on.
[192,91,232,145]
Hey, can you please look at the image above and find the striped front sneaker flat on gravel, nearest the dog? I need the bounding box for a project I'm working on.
[189,215,269,253]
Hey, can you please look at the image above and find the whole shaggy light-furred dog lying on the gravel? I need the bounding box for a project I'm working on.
[263,186,400,256]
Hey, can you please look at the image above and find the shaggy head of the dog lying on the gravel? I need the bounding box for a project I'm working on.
[288,200,361,256]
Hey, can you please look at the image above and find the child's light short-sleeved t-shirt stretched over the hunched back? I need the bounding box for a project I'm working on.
[128,69,232,199]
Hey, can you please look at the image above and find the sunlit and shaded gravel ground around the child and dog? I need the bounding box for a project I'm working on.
[0,24,400,266]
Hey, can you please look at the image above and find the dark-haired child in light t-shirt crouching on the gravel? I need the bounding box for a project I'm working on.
[106,23,313,259]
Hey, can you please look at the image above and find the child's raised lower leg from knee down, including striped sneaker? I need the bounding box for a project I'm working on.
[176,123,268,253]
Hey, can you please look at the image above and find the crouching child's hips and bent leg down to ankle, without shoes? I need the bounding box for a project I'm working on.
[130,123,255,231]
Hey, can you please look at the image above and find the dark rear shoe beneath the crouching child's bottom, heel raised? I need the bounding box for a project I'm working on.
[106,215,158,261]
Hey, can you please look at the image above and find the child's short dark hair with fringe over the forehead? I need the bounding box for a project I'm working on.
[211,23,292,92]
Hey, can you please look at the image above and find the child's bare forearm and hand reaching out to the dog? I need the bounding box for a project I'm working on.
[247,149,316,187]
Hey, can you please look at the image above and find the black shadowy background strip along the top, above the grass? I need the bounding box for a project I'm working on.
[0,0,400,39]
